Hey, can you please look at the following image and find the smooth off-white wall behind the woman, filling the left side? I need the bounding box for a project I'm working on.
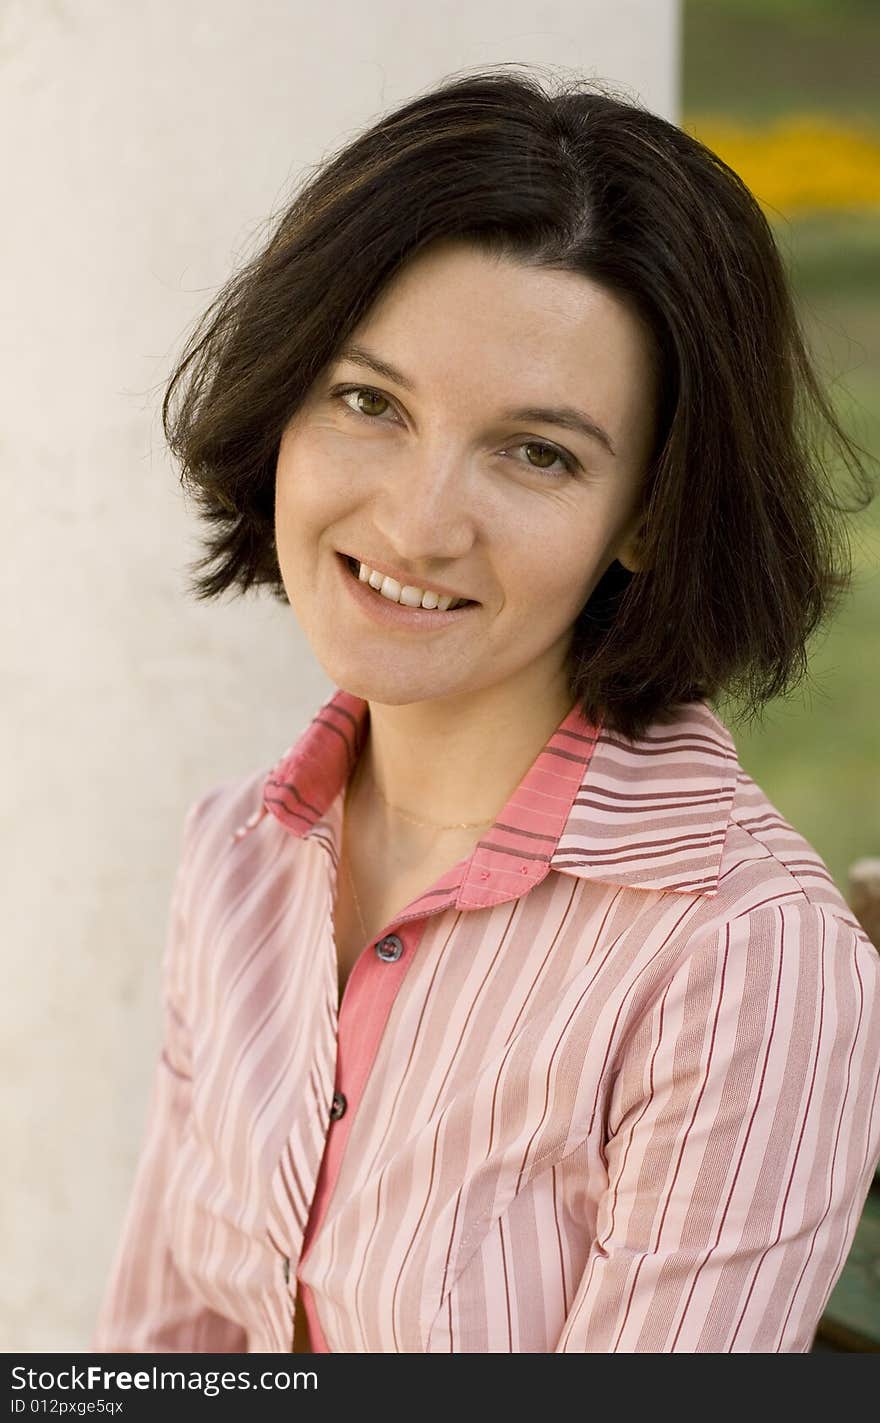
[0,0,679,1352]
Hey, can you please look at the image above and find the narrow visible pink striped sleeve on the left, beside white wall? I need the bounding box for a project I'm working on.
[90,803,248,1353]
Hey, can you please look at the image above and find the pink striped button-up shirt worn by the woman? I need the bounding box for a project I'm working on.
[91,692,880,1353]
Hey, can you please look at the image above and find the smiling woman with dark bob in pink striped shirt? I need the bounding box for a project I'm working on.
[93,65,880,1353]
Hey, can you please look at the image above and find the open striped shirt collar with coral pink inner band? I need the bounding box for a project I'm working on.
[235,690,739,919]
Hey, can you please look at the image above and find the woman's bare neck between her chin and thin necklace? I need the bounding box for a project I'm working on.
[350,663,572,841]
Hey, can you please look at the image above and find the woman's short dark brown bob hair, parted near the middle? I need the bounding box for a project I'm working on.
[162,64,873,739]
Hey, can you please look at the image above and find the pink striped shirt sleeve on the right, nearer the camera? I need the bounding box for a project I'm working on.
[555,899,880,1353]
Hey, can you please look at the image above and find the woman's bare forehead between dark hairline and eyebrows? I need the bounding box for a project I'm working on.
[338,242,655,448]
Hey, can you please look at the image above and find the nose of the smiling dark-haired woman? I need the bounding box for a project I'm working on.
[373,447,477,565]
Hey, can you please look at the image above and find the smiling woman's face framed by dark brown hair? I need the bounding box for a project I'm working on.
[275,240,655,717]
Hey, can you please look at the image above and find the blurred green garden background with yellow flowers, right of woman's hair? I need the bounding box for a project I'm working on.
[681,0,880,894]
